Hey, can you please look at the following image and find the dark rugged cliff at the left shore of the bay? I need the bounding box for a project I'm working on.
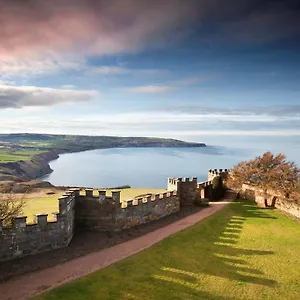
[0,151,58,181]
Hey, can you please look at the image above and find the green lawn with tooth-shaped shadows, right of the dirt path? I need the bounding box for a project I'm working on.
[35,202,300,300]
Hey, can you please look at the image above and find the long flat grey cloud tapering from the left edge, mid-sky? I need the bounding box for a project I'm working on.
[0,85,97,109]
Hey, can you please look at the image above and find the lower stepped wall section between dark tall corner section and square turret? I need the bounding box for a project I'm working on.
[115,191,180,231]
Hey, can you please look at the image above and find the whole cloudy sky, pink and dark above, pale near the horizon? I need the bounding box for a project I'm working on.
[0,0,300,148]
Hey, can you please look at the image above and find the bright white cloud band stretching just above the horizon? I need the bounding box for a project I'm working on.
[1,111,300,137]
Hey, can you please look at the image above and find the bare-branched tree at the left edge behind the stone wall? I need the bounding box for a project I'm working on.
[0,193,25,226]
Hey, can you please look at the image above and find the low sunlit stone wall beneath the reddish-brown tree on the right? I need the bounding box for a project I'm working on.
[240,184,300,218]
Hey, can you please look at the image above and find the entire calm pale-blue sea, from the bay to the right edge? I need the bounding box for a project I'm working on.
[41,137,300,188]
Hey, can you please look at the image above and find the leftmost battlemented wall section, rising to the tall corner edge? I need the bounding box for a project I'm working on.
[0,191,75,261]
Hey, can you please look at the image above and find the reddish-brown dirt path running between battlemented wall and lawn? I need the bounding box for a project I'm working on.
[0,200,231,300]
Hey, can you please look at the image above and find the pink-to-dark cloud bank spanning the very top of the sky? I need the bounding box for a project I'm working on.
[0,0,300,61]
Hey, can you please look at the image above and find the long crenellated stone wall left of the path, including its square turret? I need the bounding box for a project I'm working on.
[0,172,220,261]
